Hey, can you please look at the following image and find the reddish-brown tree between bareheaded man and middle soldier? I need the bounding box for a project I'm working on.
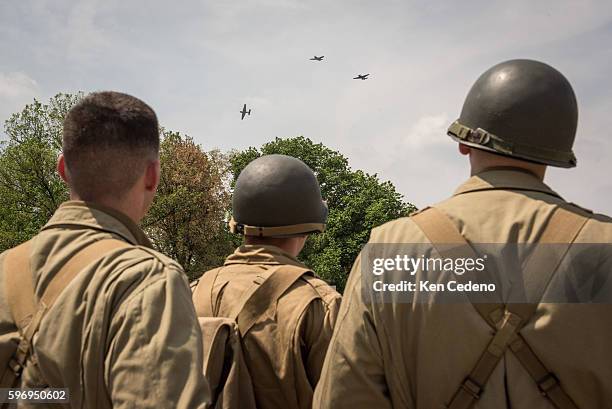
[142,131,233,278]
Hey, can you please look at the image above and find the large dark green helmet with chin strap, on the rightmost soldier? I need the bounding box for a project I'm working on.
[448,60,578,168]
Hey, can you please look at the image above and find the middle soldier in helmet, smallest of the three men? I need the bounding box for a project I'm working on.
[193,155,340,409]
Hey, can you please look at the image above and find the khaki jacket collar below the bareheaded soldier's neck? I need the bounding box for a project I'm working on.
[43,200,152,247]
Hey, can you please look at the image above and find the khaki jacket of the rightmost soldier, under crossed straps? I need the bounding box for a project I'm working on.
[313,169,612,409]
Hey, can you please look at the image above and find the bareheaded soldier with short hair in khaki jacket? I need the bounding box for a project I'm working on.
[0,92,209,408]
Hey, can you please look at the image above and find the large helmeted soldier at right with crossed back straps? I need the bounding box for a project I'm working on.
[313,60,612,409]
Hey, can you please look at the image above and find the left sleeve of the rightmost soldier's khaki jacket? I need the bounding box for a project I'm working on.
[313,253,392,409]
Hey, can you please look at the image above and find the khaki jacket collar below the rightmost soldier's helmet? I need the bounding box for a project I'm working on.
[454,167,562,199]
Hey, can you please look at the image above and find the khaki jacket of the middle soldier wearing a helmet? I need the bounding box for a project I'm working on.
[194,245,341,409]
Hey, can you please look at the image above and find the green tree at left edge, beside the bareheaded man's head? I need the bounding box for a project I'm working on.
[0,93,82,251]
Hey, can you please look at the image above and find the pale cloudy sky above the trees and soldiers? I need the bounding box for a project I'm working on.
[0,0,612,214]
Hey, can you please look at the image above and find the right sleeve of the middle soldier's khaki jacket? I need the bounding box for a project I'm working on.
[302,288,341,389]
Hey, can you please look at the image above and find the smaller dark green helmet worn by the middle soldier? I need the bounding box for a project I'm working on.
[230,155,328,237]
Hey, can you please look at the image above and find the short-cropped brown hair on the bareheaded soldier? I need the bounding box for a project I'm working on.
[62,91,159,201]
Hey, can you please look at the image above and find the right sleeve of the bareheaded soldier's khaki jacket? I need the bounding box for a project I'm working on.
[106,262,210,409]
